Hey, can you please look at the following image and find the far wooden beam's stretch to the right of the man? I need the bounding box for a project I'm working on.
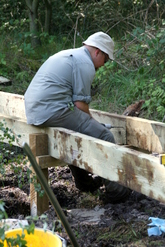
[91,110,165,153]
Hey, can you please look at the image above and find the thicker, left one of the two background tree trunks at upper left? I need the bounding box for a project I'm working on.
[26,0,40,47]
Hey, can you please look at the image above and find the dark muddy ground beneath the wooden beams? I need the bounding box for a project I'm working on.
[0,162,165,247]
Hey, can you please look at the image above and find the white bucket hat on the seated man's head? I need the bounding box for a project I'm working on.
[83,32,114,60]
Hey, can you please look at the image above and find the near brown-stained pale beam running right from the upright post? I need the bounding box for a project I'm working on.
[48,128,165,203]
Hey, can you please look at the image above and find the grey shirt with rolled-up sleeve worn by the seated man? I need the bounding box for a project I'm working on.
[24,46,95,125]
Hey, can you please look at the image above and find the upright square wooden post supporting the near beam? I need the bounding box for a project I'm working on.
[29,133,49,216]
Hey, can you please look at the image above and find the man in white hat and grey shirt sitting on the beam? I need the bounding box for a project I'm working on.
[25,32,130,203]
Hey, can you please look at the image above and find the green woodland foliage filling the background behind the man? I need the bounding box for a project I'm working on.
[0,0,165,120]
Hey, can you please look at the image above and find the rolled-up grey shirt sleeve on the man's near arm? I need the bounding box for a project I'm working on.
[72,63,95,104]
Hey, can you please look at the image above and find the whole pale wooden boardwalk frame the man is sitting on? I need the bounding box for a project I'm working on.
[0,92,165,214]
